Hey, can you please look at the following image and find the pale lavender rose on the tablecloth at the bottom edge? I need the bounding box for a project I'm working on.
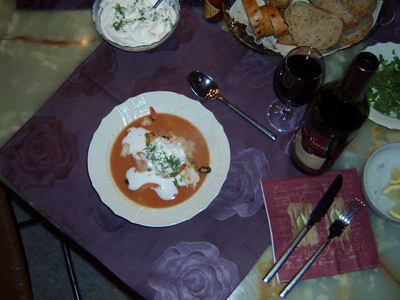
[148,242,239,300]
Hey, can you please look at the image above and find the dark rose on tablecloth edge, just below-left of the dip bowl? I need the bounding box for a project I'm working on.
[60,47,118,98]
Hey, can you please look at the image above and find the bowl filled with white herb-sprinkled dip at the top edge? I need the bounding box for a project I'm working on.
[92,0,180,52]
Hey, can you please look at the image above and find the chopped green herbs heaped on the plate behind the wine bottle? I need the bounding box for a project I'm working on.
[366,50,400,119]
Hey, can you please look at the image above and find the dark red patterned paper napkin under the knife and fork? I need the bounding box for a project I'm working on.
[262,169,379,282]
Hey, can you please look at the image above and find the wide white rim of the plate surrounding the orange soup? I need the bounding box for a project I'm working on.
[88,92,230,227]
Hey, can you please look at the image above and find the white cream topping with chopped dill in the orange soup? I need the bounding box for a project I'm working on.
[121,127,200,200]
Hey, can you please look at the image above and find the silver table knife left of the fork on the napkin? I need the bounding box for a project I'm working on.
[263,174,343,283]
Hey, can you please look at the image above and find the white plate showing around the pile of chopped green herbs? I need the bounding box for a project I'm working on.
[365,42,400,130]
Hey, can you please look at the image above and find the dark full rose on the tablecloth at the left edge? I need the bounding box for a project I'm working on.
[0,117,79,190]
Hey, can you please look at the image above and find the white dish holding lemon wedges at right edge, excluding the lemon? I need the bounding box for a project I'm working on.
[362,143,400,223]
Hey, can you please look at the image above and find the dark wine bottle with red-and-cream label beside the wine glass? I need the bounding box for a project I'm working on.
[291,52,379,175]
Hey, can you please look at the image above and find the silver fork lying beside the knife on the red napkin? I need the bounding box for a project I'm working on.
[280,198,365,298]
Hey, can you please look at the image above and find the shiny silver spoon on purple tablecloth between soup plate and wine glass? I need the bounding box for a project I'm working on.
[187,71,276,141]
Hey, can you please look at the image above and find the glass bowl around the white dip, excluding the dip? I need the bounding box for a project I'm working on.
[92,0,181,52]
